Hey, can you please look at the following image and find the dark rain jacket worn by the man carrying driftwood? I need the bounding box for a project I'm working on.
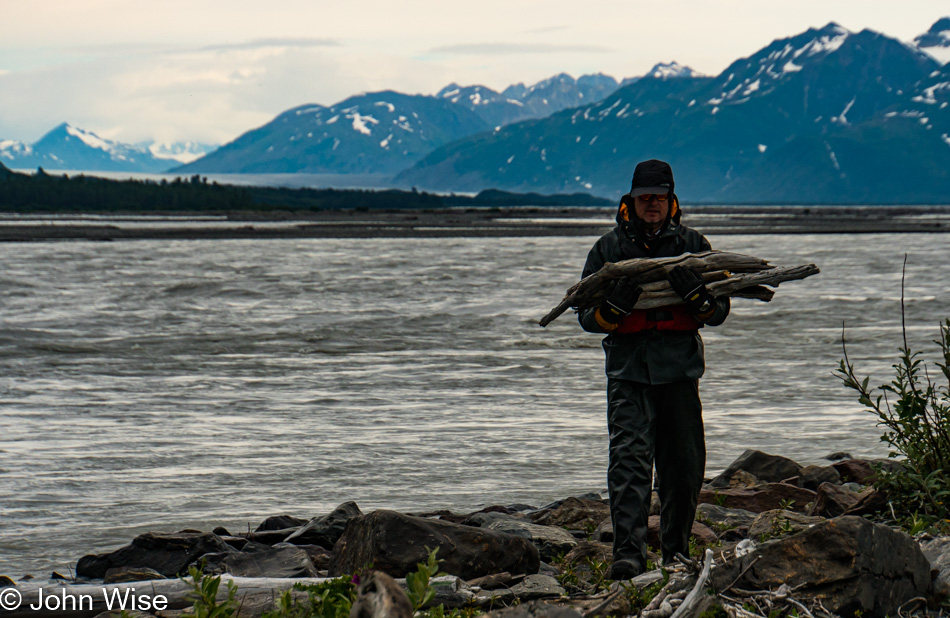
[577,205,729,384]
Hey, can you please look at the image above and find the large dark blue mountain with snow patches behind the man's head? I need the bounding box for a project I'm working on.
[397,23,950,203]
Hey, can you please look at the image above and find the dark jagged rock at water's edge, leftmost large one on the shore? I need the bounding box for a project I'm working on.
[76,532,234,579]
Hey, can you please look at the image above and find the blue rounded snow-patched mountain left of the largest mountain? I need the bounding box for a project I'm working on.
[173,90,490,174]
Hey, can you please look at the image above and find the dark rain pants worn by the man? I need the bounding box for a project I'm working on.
[607,378,706,567]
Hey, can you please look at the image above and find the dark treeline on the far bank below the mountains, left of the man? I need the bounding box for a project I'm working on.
[0,165,612,214]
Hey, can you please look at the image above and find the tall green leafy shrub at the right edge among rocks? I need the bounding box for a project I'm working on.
[835,264,950,525]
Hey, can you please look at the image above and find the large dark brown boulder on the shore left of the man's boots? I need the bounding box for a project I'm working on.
[329,510,540,580]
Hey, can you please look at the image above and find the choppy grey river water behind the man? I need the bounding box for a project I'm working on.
[0,229,950,577]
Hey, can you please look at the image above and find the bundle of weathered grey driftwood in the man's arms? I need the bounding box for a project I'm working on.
[539,251,819,326]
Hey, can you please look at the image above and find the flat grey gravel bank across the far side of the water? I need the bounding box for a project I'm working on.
[0,206,950,242]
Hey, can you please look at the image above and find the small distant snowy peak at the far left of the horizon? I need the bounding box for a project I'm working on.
[0,122,170,172]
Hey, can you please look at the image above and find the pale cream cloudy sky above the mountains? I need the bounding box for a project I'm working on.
[0,0,950,144]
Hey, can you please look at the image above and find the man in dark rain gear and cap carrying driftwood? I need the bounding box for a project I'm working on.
[578,159,729,580]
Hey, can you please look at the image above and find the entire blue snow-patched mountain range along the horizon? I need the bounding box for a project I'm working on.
[0,18,950,203]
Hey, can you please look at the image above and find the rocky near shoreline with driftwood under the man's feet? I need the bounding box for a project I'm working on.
[0,451,950,618]
